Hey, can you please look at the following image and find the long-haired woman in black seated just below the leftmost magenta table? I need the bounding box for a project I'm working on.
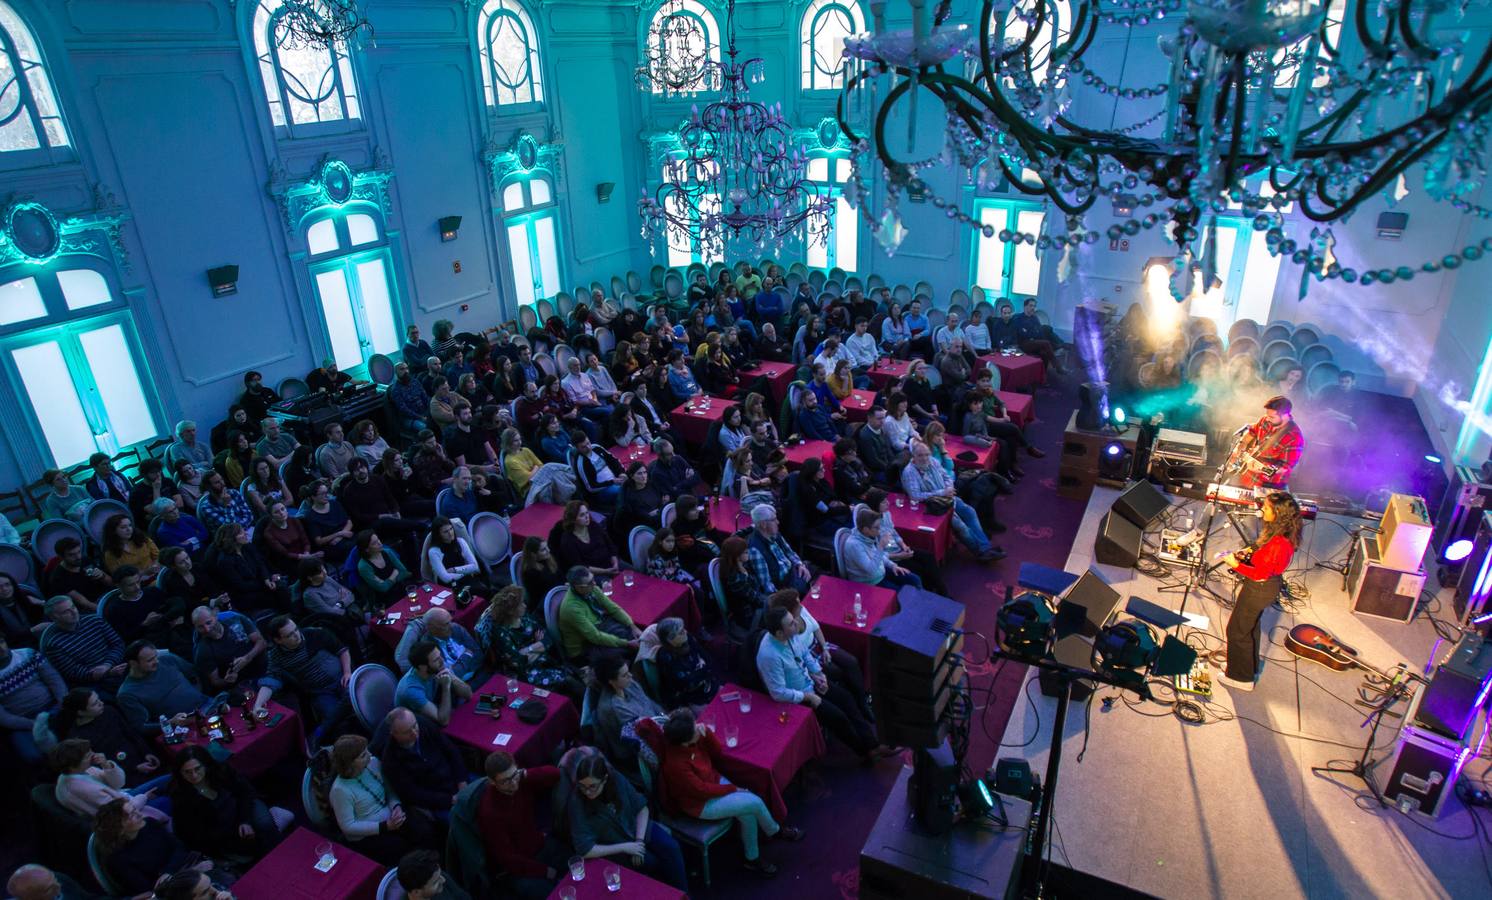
[167,745,292,863]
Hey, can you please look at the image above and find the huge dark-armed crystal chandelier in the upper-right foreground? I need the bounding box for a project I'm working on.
[839,0,1492,299]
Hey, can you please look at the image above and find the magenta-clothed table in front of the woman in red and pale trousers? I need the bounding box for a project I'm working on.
[700,684,827,822]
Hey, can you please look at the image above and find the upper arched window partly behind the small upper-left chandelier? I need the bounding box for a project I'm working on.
[254,0,363,134]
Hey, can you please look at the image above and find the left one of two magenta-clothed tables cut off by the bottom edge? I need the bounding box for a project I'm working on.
[233,828,384,900]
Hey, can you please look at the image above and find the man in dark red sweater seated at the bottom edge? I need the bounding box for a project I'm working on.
[477,751,565,900]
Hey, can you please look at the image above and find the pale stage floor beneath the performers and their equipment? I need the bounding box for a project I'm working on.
[997,488,1492,900]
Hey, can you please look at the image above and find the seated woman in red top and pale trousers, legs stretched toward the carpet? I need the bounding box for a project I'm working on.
[637,707,803,878]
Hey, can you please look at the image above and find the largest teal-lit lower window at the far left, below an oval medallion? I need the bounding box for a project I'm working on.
[0,258,163,466]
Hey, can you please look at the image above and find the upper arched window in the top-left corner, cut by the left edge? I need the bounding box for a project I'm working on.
[0,0,72,160]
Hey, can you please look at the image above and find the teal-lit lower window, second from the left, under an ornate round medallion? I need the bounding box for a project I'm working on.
[306,207,400,370]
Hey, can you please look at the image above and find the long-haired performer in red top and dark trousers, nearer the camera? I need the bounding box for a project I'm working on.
[1220,491,1301,691]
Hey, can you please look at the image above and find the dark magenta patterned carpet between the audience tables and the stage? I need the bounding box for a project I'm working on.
[698,376,1086,900]
